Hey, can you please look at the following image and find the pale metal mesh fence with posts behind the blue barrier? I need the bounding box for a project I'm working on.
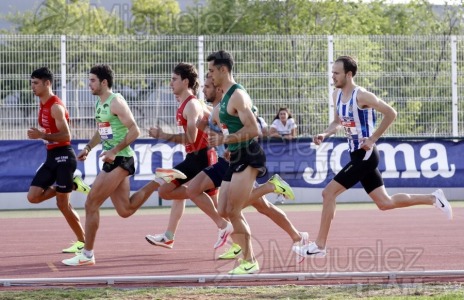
[0,35,464,140]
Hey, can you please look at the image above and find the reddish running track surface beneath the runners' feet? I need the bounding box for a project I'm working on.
[0,205,464,285]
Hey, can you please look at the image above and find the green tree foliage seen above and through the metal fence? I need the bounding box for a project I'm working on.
[0,0,464,134]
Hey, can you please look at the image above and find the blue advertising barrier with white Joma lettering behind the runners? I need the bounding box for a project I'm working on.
[0,138,464,193]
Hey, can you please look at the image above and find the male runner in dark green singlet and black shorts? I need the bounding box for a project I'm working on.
[206,50,266,275]
